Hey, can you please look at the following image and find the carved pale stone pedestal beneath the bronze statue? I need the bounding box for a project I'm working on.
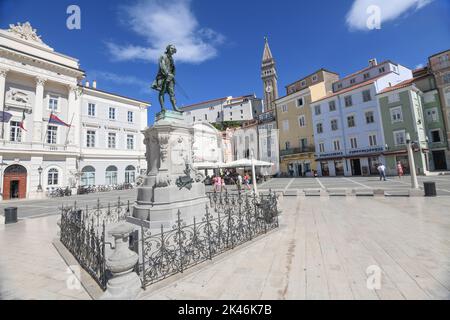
[128,111,208,230]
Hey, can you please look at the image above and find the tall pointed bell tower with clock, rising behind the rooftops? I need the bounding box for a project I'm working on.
[261,37,278,111]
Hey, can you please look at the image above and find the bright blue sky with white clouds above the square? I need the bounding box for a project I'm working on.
[0,0,450,123]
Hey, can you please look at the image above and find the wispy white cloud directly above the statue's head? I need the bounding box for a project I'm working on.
[107,0,224,63]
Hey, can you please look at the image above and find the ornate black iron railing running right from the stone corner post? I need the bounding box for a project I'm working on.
[138,192,278,289]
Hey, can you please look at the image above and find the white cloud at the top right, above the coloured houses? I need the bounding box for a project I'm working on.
[346,0,434,30]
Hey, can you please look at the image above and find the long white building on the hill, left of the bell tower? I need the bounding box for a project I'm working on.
[182,95,263,124]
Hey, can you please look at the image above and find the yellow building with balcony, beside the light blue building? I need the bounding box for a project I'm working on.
[275,69,339,176]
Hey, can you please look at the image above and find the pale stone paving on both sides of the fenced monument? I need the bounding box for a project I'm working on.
[0,190,450,299]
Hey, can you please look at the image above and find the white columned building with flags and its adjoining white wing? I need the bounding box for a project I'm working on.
[0,23,150,200]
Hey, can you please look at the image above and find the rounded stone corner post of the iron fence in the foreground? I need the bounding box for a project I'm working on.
[101,222,141,300]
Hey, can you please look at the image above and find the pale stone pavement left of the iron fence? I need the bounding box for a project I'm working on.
[0,216,90,300]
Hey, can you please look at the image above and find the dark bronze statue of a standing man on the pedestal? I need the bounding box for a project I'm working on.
[152,44,182,112]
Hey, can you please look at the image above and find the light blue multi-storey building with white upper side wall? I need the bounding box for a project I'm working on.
[311,59,412,176]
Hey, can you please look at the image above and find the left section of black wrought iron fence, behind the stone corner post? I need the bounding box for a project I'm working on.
[60,198,130,290]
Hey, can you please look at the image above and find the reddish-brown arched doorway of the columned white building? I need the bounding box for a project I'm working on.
[3,164,27,200]
